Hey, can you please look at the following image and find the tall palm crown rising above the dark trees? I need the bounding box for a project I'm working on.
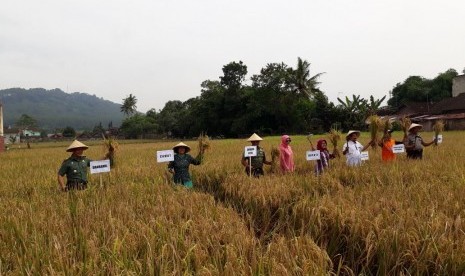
[292,57,324,98]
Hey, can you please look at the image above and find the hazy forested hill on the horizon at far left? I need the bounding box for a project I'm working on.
[0,88,124,130]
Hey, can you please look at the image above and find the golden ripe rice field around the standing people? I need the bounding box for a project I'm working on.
[0,132,465,275]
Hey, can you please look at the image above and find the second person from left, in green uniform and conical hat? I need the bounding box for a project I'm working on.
[168,142,203,188]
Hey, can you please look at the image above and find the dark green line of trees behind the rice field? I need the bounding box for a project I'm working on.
[121,58,457,138]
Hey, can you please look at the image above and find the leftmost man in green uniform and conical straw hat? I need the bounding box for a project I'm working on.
[58,140,91,191]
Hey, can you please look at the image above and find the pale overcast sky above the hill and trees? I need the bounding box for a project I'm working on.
[0,0,465,112]
